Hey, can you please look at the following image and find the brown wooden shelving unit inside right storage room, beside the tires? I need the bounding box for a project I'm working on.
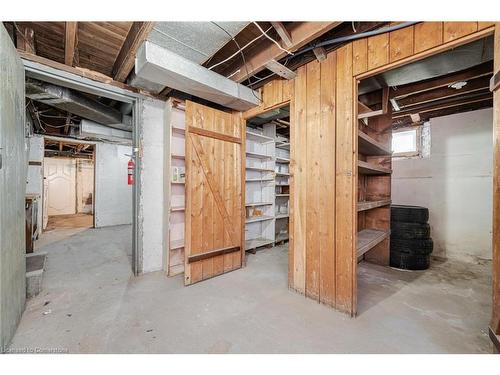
[356,89,392,265]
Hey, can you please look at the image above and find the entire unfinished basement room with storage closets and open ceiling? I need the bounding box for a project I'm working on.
[0,3,500,373]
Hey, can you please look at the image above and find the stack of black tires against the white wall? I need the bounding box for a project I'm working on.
[390,205,434,270]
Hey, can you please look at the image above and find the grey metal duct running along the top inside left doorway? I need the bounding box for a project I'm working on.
[26,79,132,132]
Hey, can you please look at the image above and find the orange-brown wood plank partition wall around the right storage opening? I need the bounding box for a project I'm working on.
[244,22,500,316]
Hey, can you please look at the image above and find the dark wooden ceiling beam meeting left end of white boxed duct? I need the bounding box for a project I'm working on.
[112,22,155,82]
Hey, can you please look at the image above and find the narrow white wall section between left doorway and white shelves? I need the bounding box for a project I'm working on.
[138,99,170,273]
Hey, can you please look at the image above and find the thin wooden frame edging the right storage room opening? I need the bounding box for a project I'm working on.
[352,23,500,326]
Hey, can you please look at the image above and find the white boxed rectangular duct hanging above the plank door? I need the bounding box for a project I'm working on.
[135,42,260,111]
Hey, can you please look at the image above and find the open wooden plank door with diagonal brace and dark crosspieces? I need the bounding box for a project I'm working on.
[184,101,245,285]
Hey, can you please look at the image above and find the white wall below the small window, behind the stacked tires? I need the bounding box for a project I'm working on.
[392,109,493,260]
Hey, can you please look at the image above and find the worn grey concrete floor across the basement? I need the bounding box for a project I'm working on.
[11,226,491,353]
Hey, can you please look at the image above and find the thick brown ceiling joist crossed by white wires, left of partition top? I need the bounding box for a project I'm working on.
[231,22,341,82]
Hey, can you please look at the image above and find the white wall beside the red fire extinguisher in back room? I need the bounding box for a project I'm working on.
[95,143,132,228]
